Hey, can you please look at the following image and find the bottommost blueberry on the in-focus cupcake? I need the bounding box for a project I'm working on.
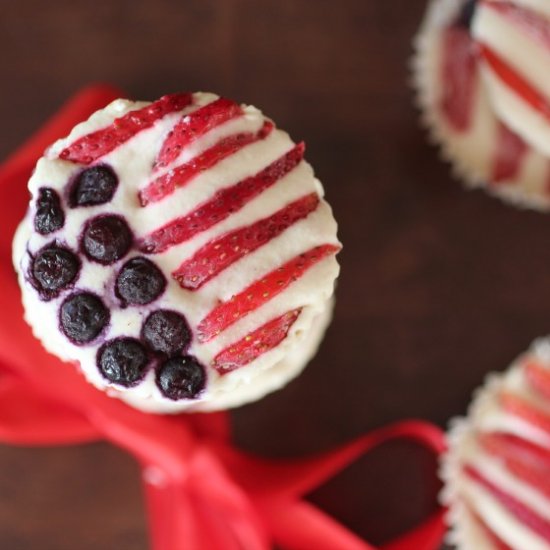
[157,355,206,401]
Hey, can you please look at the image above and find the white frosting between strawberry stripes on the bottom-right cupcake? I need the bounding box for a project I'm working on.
[442,339,550,550]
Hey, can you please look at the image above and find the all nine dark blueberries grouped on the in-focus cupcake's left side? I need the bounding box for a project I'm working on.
[29,165,206,400]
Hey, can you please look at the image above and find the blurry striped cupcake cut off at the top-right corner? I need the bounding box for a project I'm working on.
[413,0,550,210]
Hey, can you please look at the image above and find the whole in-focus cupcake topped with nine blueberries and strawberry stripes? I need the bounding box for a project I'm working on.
[13,93,340,412]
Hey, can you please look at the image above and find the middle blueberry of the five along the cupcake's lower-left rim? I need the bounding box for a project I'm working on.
[60,292,109,344]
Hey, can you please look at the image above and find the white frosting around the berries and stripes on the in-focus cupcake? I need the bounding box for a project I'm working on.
[13,93,339,413]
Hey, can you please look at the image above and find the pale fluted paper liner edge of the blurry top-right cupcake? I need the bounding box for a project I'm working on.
[410,0,550,211]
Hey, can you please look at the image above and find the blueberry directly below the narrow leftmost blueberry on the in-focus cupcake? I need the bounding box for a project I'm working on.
[32,245,80,297]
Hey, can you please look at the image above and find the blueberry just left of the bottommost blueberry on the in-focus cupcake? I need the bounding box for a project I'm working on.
[97,338,148,387]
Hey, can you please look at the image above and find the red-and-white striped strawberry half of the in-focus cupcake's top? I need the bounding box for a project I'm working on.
[55,93,340,408]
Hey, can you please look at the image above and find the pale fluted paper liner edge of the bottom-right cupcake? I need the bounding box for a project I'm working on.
[439,337,550,550]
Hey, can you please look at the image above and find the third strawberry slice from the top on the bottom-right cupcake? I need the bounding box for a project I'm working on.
[479,433,550,498]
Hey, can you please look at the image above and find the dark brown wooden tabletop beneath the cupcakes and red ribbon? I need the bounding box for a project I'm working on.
[0,0,550,550]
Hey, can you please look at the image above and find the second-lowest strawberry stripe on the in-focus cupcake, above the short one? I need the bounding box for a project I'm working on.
[197,244,340,342]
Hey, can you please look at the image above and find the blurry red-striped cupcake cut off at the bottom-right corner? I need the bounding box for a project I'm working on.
[443,339,550,550]
